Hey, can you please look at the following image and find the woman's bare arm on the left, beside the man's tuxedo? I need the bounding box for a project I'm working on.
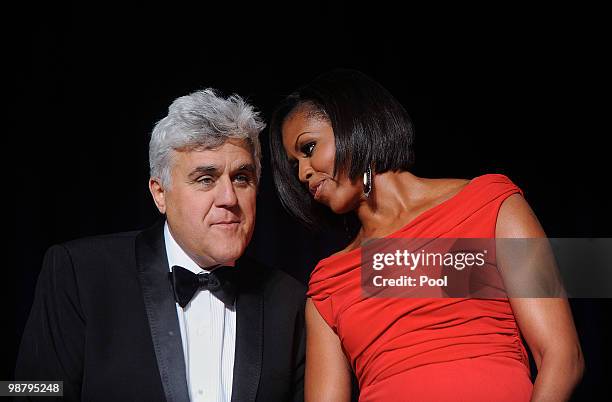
[304,298,351,402]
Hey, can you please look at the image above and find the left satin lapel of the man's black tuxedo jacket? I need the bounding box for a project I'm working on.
[135,220,189,402]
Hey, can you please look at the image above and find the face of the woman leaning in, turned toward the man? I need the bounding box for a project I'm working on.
[282,107,363,214]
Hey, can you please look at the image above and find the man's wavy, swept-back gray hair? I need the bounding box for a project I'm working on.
[149,88,265,188]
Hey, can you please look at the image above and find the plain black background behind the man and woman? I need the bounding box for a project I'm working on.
[10,2,612,400]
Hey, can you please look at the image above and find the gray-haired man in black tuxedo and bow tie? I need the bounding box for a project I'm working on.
[15,89,305,402]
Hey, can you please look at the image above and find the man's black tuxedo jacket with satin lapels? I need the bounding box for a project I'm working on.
[15,222,305,402]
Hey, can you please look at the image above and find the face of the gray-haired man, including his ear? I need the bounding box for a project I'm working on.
[149,140,257,267]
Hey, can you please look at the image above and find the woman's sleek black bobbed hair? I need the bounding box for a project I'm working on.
[270,70,414,228]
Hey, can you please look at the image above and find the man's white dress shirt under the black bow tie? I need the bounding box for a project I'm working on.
[164,222,236,402]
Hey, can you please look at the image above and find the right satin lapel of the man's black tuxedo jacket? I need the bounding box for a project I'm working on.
[232,258,263,402]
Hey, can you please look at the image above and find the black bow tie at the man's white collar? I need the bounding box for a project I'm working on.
[168,265,236,308]
